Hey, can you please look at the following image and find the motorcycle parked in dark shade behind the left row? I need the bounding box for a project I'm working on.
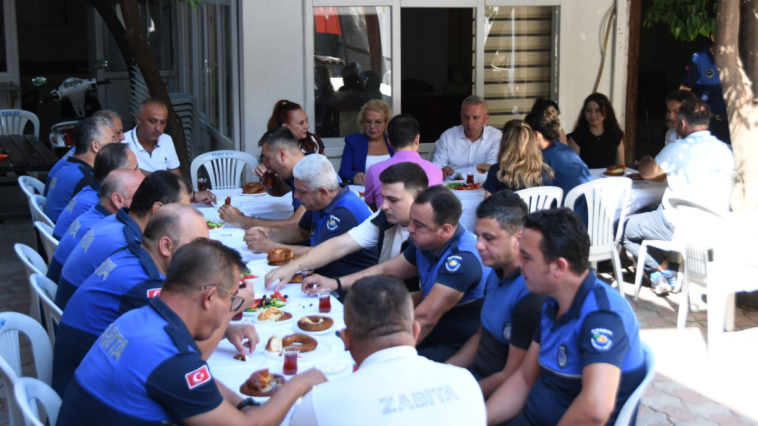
[32,59,111,148]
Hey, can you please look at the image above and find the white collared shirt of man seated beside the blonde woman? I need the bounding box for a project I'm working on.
[432,125,503,179]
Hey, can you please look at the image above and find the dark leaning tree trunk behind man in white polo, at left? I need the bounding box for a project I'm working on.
[121,0,190,178]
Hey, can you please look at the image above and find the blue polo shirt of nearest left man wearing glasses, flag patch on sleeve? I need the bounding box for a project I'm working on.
[57,298,224,426]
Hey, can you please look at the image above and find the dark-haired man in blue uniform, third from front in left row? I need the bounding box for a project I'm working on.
[55,170,192,310]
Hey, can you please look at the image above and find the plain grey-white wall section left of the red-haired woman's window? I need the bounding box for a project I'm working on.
[240,0,305,154]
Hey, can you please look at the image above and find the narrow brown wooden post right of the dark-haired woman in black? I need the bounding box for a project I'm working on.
[624,0,642,167]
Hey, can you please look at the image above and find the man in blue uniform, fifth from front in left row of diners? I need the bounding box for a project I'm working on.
[53,143,137,241]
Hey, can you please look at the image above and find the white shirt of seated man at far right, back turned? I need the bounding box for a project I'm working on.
[655,130,735,224]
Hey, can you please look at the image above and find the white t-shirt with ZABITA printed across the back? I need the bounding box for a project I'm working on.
[290,346,487,426]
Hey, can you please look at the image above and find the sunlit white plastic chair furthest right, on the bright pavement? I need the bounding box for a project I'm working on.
[669,198,758,353]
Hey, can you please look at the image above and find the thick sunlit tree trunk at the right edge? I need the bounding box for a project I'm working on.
[714,0,758,211]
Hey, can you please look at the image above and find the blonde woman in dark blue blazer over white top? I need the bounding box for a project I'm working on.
[339,99,395,185]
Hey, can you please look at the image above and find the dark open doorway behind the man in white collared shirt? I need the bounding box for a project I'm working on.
[400,8,475,143]
